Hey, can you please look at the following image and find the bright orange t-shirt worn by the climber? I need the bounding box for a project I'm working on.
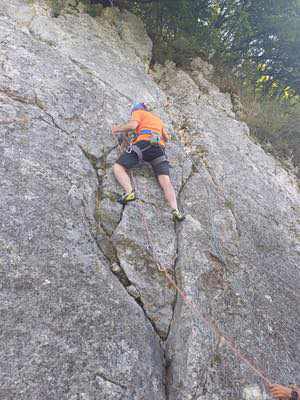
[131,110,164,144]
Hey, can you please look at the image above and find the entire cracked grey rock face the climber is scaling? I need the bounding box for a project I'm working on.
[0,0,300,400]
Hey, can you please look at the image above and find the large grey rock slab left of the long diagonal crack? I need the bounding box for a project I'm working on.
[0,1,165,400]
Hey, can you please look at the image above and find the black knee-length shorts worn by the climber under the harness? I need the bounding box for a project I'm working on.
[116,140,170,176]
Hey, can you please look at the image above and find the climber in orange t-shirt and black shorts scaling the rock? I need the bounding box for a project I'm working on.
[112,103,185,221]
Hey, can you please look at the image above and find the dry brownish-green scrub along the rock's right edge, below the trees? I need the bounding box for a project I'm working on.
[213,60,300,177]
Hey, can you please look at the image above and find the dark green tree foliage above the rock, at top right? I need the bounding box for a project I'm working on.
[120,0,300,95]
